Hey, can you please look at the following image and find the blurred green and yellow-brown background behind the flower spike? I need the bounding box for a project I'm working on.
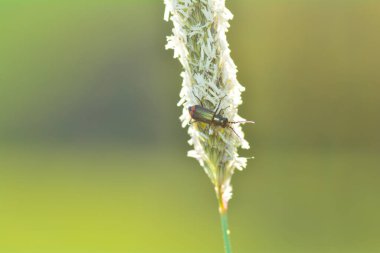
[0,0,380,253]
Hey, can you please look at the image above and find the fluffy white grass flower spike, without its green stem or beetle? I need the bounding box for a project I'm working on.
[165,0,249,213]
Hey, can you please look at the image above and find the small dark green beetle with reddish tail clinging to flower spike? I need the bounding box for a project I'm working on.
[188,94,255,138]
